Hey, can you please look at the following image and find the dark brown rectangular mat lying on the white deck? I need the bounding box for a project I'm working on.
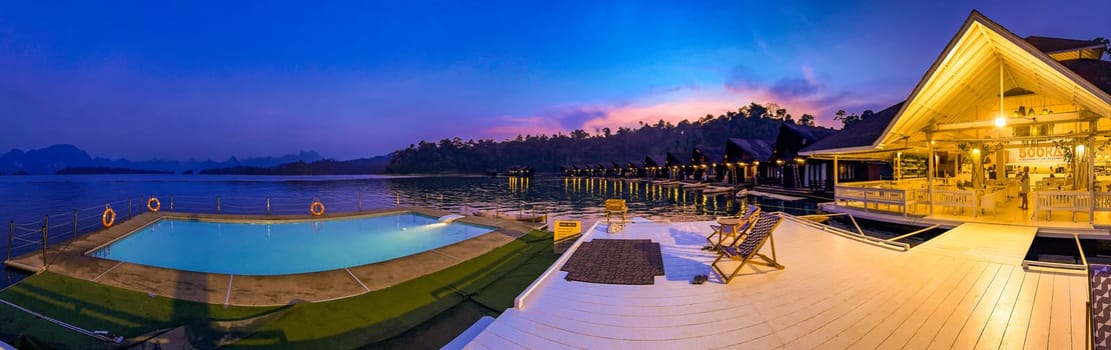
[561,239,663,284]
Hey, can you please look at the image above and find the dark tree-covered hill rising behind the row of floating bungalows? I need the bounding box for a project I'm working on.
[387,103,835,173]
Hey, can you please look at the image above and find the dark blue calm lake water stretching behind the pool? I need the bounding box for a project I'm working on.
[0,174,815,288]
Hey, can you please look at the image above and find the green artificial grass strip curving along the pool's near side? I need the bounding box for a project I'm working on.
[0,231,558,349]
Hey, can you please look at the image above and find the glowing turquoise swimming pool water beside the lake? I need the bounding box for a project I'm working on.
[90,213,493,276]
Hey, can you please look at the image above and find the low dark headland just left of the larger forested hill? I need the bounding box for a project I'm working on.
[200,153,393,176]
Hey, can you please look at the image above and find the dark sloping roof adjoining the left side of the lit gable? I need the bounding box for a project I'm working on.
[799,101,905,154]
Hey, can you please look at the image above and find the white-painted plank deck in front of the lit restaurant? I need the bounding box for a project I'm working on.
[468,216,1088,349]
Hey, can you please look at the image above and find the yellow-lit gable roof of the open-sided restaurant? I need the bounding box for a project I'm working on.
[872,11,1111,149]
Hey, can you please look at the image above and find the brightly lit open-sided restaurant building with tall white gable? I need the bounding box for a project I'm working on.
[799,11,1111,228]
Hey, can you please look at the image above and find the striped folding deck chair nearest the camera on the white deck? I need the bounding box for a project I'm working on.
[710,213,783,284]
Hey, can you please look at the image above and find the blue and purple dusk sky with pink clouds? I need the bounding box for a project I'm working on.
[0,0,1111,160]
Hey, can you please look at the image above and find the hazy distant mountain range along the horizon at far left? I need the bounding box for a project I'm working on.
[0,144,324,174]
